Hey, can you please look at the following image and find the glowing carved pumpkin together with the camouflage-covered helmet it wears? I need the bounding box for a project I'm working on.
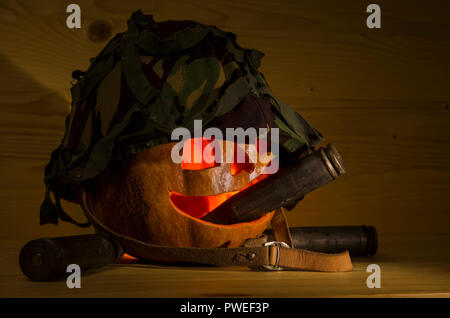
[41,11,321,258]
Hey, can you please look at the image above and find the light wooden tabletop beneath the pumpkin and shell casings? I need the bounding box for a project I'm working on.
[0,235,450,298]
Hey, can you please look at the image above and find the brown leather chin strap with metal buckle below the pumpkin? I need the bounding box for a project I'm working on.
[80,191,353,272]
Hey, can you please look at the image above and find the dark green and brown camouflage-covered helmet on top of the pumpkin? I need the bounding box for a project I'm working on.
[40,11,322,226]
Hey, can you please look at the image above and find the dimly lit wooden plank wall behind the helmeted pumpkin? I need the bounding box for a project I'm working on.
[0,0,450,238]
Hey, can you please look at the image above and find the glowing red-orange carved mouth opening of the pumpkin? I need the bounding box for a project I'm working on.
[169,170,269,219]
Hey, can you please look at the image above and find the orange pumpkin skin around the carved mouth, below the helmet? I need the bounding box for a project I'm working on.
[86,143,273,248]
